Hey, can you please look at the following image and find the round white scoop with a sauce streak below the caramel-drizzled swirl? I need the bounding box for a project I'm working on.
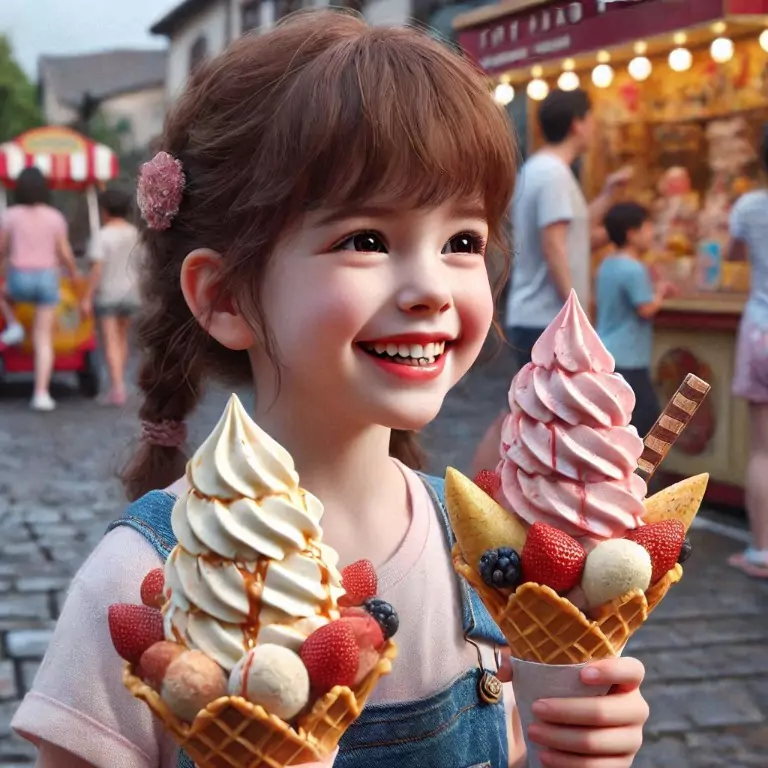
[229,644,309,720]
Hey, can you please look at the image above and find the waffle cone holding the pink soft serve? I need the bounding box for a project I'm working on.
[453,547,683,664]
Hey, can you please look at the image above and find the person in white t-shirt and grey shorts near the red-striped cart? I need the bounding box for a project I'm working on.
[83,189,141,406]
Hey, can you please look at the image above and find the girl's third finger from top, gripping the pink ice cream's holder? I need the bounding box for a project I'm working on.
[528,723,643,768]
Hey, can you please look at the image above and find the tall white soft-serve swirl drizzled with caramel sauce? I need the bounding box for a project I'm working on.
[165,395,344,670]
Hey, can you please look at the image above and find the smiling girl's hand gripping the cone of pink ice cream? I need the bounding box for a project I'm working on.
[528,658,648,768]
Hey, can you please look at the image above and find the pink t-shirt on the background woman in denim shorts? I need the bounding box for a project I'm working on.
[2,205,67,270]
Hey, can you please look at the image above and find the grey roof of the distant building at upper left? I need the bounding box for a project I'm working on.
[40,49,168,106]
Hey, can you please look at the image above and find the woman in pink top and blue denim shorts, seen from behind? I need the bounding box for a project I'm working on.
[0,168,77,411]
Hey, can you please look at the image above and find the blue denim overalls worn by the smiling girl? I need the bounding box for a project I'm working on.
[109,475,508,768]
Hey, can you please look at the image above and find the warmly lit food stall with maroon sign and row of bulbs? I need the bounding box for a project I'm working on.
[454,0,768,506]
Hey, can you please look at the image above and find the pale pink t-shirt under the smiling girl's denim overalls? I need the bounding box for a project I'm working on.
[12,465,521,768]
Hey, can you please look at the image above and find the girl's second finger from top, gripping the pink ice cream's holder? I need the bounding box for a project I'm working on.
[533,690,649,728]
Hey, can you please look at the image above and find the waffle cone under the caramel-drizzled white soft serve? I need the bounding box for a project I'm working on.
[123,641,397,768]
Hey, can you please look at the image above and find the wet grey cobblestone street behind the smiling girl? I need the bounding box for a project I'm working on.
[0,358,768,768]
